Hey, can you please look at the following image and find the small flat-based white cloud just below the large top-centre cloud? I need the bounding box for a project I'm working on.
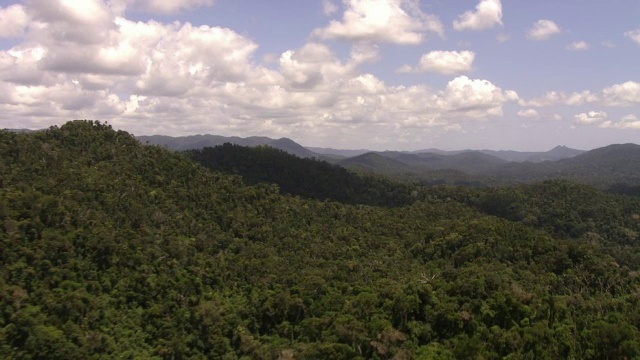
[398,51,476,75]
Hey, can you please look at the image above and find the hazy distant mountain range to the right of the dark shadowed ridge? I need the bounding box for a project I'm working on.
[338,144,640,190]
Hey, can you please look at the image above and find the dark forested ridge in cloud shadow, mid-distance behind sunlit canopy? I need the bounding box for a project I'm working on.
[185,143,417,207]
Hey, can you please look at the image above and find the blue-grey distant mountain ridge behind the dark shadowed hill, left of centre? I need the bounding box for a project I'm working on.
[137,135,320,158]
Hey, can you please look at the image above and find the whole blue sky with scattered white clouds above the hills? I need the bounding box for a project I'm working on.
[0,0,640,151]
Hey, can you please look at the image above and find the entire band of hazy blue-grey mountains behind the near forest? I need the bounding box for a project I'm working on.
[138,135,640,189]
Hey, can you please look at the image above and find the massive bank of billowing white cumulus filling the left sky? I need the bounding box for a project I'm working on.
[0,0,518,146]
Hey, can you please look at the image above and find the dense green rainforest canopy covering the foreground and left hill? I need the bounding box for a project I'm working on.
[0,121,640,359]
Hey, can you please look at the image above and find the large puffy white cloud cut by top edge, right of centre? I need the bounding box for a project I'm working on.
[313,0,444,45]
